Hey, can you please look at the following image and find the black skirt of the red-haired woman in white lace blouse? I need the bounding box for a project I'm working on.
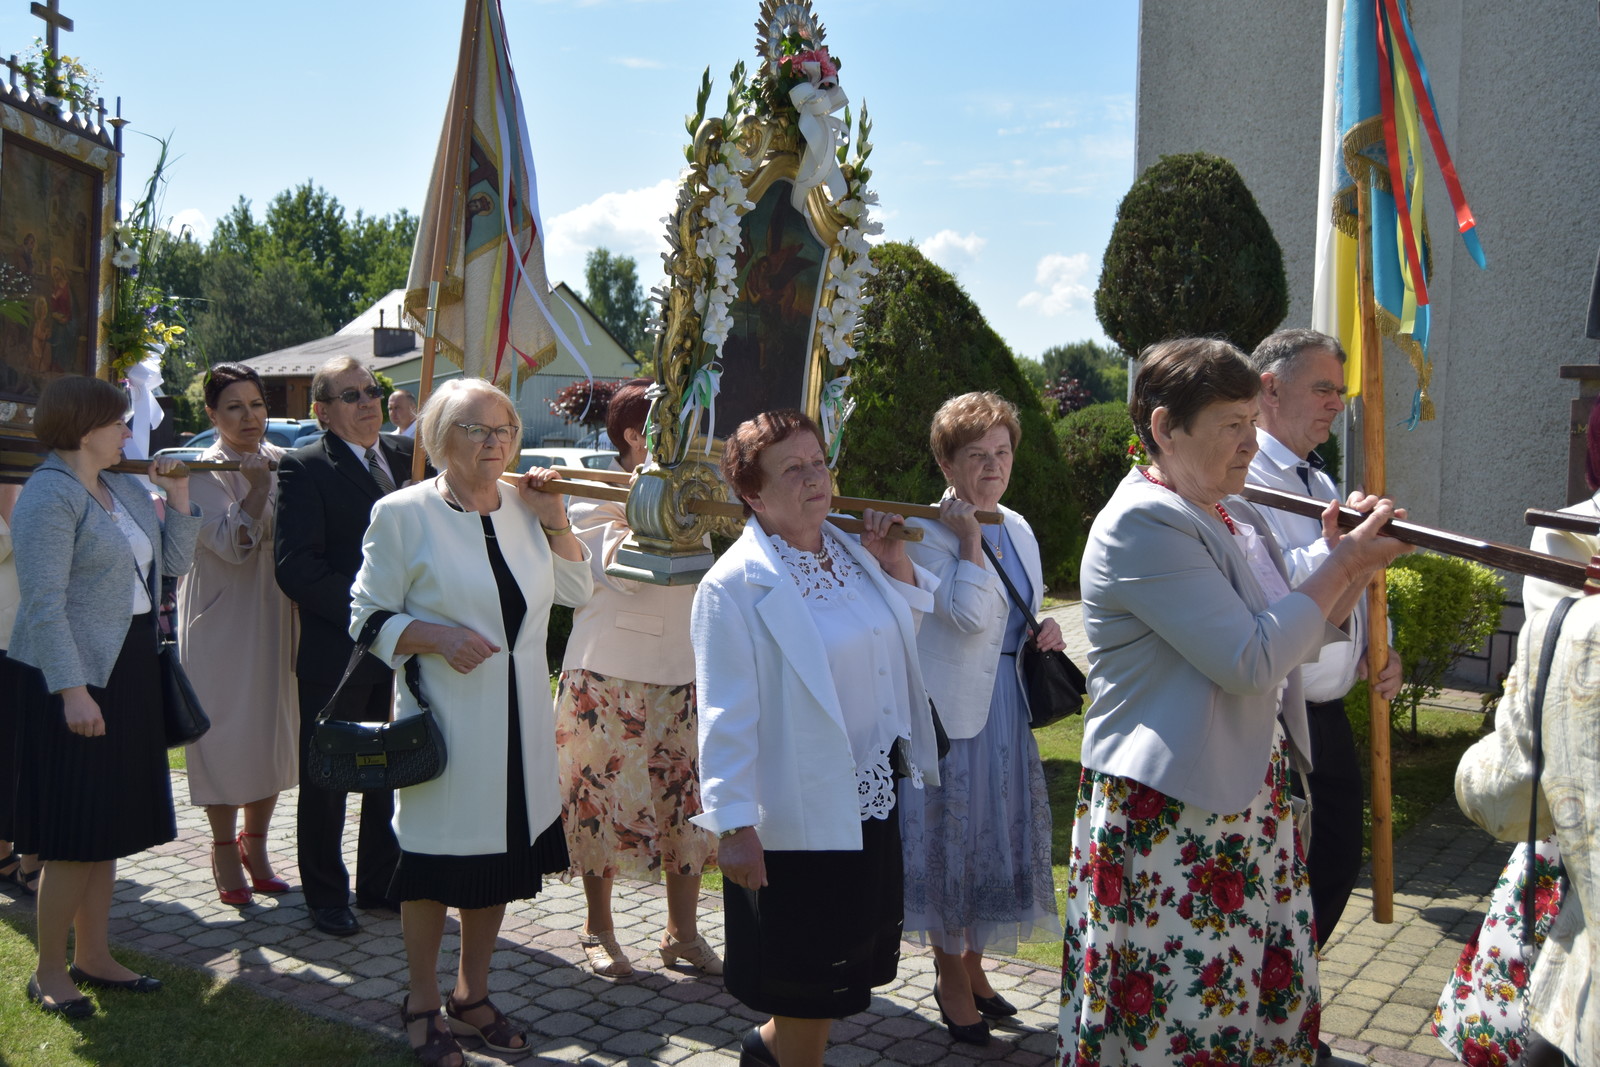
[723,813,906,1019]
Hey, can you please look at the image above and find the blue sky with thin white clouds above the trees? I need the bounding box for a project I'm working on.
[0,0,1138,357]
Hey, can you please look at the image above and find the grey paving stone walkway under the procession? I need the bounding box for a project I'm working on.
[0,605,1510,1067]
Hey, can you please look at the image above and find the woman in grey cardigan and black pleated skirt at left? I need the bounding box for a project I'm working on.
[6,376,200,1017]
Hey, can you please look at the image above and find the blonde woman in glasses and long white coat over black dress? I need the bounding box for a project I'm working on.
[350,379,594,1067]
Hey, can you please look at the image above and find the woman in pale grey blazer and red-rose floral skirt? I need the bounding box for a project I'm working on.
[1059,338,1405,1064]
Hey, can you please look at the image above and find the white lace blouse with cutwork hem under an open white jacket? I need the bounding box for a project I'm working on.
[770,530,922,819]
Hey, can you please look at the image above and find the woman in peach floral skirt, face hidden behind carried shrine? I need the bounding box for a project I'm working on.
[555,378,722,979]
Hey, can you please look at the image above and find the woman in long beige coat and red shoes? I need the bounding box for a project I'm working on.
[178,363,299,907]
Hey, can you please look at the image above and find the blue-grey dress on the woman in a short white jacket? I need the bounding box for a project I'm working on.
[899,526,1061,955]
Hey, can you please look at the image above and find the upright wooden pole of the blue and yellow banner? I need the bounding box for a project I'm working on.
[1356,181,1395,933]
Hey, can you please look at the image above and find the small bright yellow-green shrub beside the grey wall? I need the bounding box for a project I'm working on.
[1387,552,1506,737]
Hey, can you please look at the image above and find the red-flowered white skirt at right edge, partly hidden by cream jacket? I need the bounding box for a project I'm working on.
[1434,837,1563,1067]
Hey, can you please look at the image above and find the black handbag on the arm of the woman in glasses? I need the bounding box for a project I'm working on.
[306,611,445,793]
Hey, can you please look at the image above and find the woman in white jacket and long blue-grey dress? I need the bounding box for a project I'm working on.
[899,392,1064,1045]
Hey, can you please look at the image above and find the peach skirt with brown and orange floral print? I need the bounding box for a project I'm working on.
[555,670,717,881]
